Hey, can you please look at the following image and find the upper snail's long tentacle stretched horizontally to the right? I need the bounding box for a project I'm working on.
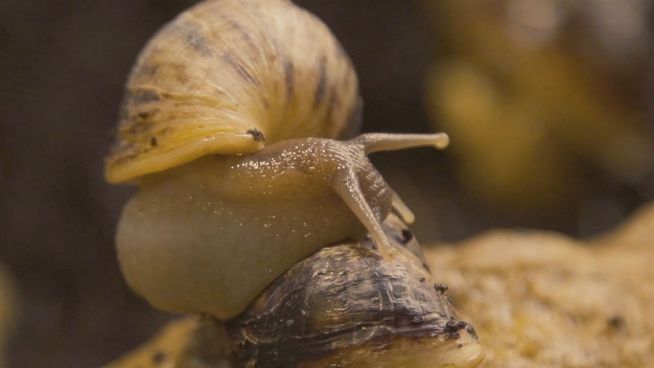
[351,133,450,154]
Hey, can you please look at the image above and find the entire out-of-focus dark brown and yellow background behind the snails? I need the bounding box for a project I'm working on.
[0,0,654,368]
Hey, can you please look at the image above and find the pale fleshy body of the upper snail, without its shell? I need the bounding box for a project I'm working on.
[117,134,448,318]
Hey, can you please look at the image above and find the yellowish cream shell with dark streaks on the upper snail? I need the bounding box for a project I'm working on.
[106,0,360,182]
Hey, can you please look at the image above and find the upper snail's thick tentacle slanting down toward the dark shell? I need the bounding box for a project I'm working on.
[333,168,395,256]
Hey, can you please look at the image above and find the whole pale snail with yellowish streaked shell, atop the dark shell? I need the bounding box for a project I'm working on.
[105,0,448,320]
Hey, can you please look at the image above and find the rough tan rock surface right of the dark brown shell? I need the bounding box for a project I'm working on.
[426,206,654,368]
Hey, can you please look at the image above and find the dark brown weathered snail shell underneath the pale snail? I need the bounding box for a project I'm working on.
[226,216,484,368]
